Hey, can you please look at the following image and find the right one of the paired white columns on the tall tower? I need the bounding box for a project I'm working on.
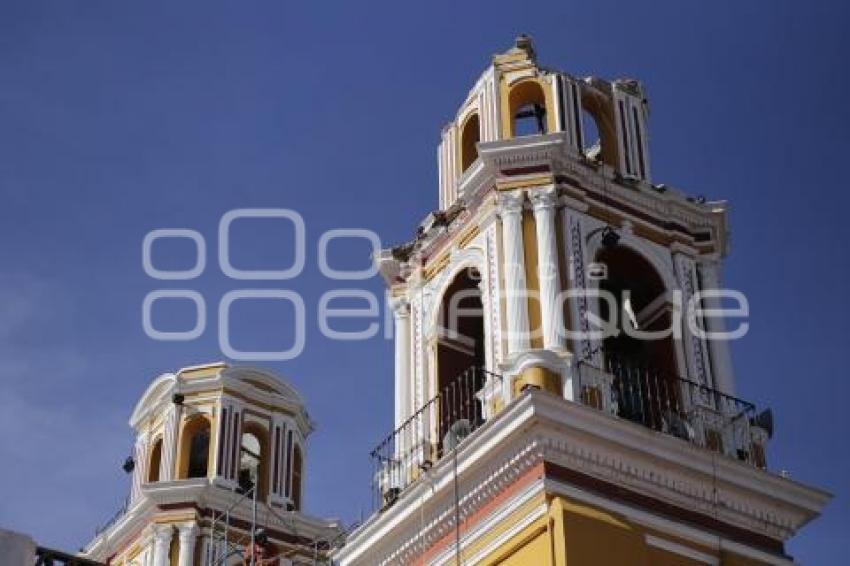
[530,187,565,351]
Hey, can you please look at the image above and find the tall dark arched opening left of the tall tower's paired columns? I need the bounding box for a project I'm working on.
[436,268,485,450]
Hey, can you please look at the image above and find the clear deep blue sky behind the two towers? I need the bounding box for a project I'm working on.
[0,0,850,564]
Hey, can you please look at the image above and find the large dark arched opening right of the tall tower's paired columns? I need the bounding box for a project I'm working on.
[597,245,679,430]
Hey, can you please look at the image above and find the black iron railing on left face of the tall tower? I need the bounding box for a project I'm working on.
[371,367,502,509]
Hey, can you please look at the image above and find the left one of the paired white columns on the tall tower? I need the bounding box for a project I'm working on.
[499,190,528,356]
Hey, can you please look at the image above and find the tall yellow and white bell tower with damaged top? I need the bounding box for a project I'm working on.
[335,36,829,566]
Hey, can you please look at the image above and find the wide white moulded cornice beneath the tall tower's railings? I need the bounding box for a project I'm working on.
[337,389,831,564]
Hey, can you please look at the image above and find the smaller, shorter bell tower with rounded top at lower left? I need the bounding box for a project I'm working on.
[83,363,342,566]
